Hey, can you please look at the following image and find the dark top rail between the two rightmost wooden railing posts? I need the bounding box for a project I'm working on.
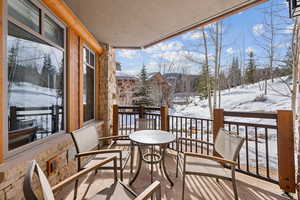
[224,111,277,119]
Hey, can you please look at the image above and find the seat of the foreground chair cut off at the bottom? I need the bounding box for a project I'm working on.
[91,181,136,200]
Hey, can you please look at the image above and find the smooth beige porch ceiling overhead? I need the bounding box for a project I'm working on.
[64,0,265,48]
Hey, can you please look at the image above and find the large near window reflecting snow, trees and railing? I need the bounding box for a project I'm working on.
[7,0,65,150]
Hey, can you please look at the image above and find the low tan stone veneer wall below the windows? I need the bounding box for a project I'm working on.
[0,121,102,200]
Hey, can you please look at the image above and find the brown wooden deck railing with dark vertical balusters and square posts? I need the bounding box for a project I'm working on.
[114,105,295,192]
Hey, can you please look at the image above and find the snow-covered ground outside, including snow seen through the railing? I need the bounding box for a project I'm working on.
[170,77,291,170]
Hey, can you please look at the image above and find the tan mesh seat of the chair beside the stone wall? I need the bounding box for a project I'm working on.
[83,151,130,169]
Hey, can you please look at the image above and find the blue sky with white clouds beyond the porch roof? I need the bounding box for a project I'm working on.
[116,0,293,75]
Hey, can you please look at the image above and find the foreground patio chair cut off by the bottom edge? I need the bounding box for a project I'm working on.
[23,156,161,200]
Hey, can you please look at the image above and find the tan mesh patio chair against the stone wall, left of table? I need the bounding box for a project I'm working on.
[71,126,132,198]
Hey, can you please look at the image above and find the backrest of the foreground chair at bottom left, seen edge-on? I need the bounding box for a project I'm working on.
[23,160,54,200]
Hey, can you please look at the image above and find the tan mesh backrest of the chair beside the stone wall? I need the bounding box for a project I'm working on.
[71,126,99,153]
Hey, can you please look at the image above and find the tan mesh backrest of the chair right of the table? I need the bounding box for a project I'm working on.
[214,128,244,161]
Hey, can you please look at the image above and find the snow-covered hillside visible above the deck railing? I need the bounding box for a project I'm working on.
[171,77,291,123]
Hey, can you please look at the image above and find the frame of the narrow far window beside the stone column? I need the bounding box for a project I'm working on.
[80,44,96,125]
